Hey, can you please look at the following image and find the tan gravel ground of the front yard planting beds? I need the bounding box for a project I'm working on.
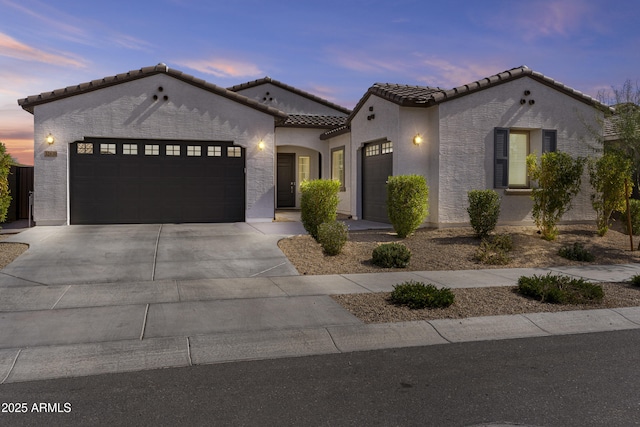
[279,224,640,323]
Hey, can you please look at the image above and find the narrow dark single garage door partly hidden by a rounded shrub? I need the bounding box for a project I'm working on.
[362,141,393,223]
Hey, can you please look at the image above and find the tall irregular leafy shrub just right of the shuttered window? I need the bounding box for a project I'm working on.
[527,152,586,240]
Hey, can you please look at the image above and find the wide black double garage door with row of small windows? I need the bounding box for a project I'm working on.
[69,138,245,224]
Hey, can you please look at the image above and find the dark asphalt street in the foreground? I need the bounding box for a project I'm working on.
[0,329,640,426]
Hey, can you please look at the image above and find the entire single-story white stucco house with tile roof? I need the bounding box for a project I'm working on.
[18,64,602,226]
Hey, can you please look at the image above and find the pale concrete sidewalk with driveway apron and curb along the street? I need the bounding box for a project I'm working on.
[0,264,640,383]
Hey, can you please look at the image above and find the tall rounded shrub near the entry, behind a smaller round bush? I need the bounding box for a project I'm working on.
[300,179,340,240]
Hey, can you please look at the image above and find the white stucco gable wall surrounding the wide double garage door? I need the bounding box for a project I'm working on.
[34,74,275,224]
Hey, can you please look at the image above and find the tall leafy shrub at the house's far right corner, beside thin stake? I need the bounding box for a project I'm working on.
[589,152,632,236]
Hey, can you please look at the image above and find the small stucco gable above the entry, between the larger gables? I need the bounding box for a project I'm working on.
[237,83,346,116]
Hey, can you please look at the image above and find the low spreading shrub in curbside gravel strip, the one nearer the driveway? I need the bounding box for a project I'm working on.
[389,280,455,309]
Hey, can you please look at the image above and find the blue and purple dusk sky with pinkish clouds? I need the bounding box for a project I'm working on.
[0,0,640,165]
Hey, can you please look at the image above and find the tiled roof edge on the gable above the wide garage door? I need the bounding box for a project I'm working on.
[18,64,287,121]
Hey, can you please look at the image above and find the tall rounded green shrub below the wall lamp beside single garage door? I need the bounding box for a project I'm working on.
[387,175,429,238]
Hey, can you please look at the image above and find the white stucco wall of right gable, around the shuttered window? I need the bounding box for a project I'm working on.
[438,77,597,224]
